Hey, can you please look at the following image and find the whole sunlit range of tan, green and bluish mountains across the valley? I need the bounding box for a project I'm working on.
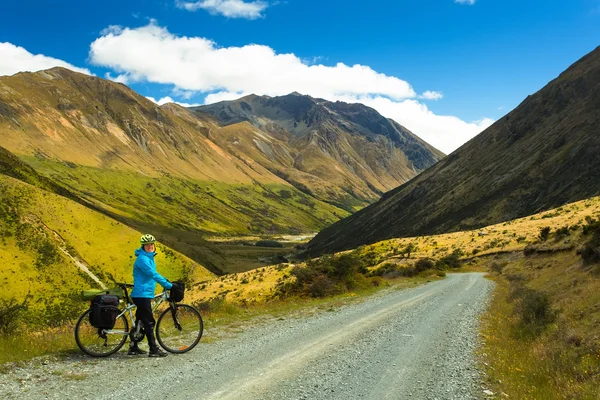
[0,68,443,272]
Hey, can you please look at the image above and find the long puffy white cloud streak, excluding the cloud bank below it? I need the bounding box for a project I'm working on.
[90,23,416,100]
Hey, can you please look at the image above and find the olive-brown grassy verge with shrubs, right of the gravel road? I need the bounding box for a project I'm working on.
[480,250,600,399]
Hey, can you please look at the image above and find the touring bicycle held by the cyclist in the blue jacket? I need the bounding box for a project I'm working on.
[75,283,204,357]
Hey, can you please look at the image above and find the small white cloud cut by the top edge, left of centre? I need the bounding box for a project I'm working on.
[175,0,269,19]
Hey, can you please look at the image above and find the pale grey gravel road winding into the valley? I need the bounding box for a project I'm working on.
[0,273,492,400]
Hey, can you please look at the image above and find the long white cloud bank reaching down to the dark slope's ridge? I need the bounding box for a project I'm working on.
[90,21,492,152]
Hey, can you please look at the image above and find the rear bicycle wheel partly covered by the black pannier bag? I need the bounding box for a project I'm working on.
[75,309,129,357]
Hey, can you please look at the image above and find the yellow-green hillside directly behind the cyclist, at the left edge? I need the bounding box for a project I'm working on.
[0,175,213,326]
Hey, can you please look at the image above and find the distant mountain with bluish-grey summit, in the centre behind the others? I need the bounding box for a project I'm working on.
[190,93,444,212]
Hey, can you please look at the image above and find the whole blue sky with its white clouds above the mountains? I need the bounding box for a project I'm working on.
[0,0,600,152]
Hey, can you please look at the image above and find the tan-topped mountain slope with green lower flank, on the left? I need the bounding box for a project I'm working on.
[0,68,348,244]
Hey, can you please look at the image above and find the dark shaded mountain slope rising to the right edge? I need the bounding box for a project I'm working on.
[308,47,600,255]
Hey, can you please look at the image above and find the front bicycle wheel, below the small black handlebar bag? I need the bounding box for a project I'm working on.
[156,304,204,353]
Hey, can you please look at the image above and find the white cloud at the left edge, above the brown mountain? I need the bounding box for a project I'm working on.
[0,42,93,76]
